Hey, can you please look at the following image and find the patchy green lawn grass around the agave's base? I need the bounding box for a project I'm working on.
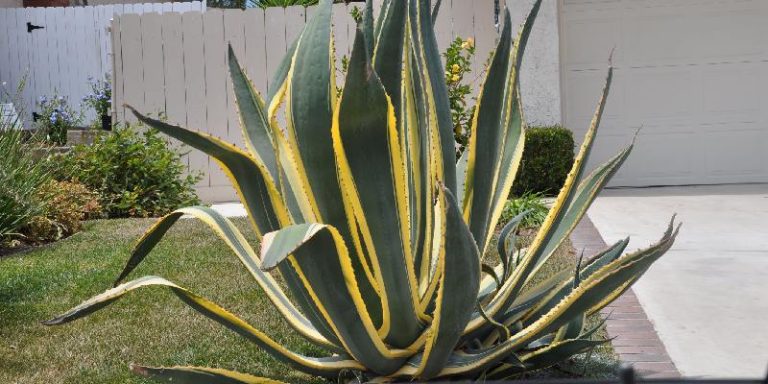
[0,219,615,384]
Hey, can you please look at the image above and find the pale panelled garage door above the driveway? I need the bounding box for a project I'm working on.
[560,0,768,186]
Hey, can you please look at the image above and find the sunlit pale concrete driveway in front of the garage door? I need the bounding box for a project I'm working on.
[589,184,768,378]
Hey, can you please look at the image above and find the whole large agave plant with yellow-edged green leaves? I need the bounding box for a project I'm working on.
[47,0,679,383]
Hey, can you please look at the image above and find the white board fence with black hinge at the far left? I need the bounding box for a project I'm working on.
[0,2,205,123]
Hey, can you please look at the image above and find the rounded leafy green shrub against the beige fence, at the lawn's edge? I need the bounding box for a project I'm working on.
[56,126,200,217]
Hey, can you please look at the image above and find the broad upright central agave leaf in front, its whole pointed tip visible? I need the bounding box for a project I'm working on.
[332,29,422,348]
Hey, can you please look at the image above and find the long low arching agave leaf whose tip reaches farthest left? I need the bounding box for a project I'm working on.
[43,276,363,377]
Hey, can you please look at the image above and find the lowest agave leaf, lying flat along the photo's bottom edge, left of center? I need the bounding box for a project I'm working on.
[130,364,282,384]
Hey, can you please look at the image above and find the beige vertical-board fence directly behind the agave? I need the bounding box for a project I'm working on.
[112,0,503,201]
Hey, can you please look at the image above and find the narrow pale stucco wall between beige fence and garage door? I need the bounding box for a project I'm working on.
[508,0,562,125]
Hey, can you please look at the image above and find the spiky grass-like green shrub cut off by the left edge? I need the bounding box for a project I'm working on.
[0,123,50,244]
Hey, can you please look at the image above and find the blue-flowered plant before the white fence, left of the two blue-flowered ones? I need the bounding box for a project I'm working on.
[36,96,83,145]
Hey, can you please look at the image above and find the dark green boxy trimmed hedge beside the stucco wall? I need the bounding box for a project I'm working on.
[511,125,574,196]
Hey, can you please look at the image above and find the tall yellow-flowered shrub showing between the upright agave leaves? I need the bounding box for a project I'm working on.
[443,37,475,157]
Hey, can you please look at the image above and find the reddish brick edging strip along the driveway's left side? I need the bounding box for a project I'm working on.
[571,216,680,378]
